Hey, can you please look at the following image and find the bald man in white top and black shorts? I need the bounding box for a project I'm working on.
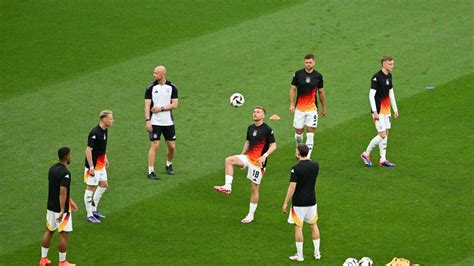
[145,66,178,180]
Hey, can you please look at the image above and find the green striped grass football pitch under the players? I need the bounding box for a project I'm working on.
[0,0,474,265]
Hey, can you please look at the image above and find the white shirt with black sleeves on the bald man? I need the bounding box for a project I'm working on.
[145,80,178,126]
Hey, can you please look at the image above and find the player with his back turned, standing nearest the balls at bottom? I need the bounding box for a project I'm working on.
[282,144,321,261]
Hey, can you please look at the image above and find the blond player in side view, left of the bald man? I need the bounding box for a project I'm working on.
[84,110,114,223]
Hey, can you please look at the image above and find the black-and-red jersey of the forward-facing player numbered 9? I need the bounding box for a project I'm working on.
[291,69,324,112]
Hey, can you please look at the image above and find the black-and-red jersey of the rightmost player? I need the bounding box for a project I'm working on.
[370,70,393,115]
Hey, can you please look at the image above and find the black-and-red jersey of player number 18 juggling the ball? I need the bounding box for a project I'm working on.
[247,123,275,167]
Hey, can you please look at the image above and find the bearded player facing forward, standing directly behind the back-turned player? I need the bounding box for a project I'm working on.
[290,54,327,158]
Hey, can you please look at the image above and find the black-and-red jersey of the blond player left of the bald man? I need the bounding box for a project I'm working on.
[85,126,108,170]
